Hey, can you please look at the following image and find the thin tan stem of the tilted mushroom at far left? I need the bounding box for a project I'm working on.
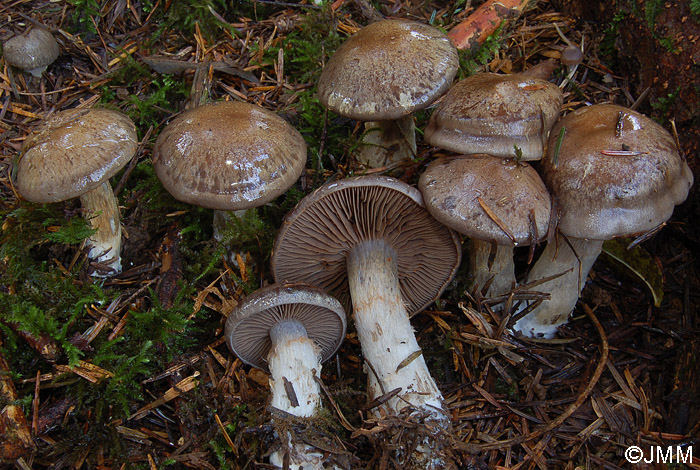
[80,181,122,277]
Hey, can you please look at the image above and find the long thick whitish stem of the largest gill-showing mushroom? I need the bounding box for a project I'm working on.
[347,240,449,423]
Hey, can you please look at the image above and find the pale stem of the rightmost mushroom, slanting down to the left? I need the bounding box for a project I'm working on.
[513,235,603,338]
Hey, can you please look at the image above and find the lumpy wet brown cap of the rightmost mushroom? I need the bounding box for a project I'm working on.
[542,104,693,240]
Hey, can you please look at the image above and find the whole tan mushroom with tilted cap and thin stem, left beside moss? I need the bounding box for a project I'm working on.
[15,108,138,276]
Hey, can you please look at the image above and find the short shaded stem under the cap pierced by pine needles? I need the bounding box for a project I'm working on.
[469,238,515,298]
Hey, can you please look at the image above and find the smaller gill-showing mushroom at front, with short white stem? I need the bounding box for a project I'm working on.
[225,283,346,470]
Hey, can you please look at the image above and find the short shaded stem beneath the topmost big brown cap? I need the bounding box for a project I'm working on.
[357,114,417,168]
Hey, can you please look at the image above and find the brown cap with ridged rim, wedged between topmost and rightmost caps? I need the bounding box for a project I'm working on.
[425,73,564,160]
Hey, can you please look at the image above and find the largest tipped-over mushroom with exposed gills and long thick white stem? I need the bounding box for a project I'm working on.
[271,175,461,468]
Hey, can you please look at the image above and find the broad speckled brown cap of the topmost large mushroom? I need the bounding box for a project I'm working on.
[318,19,459,121]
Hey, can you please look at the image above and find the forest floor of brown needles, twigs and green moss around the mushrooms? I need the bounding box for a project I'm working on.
[0,0,700,470]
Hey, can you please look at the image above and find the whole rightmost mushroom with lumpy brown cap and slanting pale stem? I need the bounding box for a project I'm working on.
[514,104,693,337]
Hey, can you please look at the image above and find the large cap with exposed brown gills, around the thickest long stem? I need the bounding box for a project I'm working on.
[271,175,461,314]
